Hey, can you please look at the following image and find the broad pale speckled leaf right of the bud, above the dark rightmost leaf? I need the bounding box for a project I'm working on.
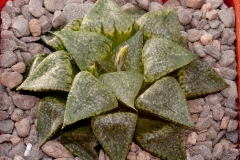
[142,38,197,82]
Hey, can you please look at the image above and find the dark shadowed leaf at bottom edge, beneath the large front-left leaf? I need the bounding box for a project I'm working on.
[61,125,98,160]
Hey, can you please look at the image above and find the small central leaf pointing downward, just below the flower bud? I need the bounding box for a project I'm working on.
[99,71,143,109]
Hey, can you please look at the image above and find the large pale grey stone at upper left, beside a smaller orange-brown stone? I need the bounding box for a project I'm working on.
[12,15,30,38]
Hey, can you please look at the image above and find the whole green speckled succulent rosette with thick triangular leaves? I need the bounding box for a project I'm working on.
[17,0,228,160]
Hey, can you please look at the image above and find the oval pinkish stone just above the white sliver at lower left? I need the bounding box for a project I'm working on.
[15,118,30,137]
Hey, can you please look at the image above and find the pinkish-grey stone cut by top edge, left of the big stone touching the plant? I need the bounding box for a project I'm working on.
[44,0,64,12]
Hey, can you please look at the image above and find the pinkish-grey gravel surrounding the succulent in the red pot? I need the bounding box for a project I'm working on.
[0,0,239,160]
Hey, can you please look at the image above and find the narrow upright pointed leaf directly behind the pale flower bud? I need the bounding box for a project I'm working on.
[113,30,143,73]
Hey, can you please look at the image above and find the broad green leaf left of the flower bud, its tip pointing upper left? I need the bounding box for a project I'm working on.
[54,31,112,71]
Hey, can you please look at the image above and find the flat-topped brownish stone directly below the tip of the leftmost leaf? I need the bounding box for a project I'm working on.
[13,94,38,110]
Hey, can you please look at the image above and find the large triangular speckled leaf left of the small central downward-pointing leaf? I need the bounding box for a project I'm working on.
[63,71,118,127]
